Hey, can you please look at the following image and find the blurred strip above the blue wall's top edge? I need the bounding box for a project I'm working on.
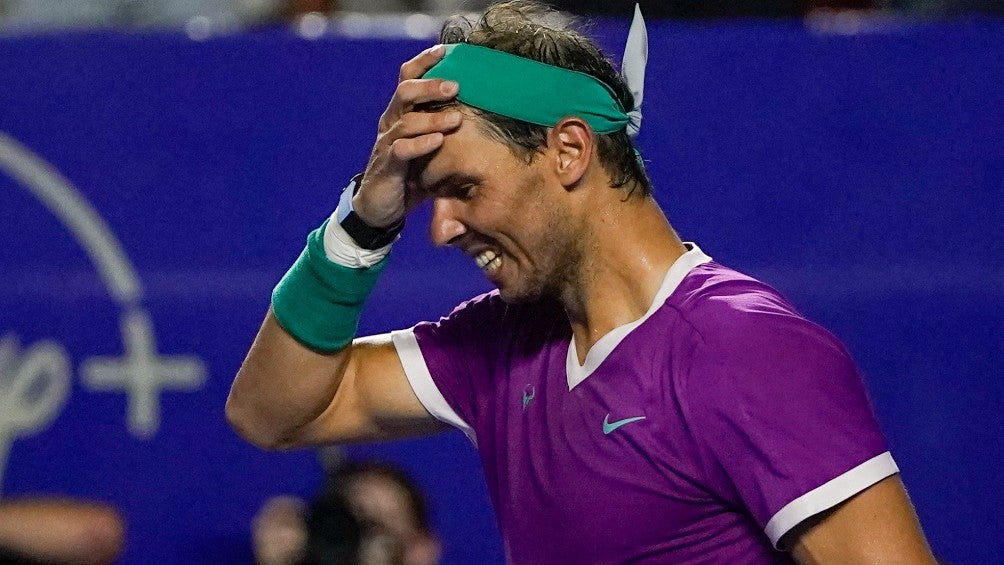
[0,0,1004,33]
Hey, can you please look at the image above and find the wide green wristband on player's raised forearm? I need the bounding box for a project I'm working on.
[272,220,388,352]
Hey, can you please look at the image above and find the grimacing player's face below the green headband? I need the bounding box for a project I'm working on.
[419,112,578,302]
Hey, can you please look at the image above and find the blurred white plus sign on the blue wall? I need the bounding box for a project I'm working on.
[80,309,206,439]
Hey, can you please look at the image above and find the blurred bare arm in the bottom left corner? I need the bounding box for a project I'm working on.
[0,499,124,565]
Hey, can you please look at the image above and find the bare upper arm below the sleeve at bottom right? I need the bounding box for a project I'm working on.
[782,475,937,565]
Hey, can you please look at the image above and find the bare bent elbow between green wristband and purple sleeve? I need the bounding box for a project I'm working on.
[227,312,440,449]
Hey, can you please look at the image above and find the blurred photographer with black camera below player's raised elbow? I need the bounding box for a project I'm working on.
[252,463,441,565]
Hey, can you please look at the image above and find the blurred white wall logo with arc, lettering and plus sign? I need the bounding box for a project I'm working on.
[0,132,206,490]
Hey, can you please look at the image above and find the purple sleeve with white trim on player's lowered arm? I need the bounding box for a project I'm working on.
[686,305,899,549]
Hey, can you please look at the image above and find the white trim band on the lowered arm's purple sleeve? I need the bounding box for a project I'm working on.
[764,452,900,549]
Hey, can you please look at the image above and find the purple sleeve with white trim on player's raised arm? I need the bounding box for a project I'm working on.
[391,293,504,445]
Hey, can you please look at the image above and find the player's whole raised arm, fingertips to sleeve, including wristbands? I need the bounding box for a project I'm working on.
[227,46,462,448]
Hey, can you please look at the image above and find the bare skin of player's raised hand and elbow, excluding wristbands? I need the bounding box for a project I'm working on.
[227,47,461,448]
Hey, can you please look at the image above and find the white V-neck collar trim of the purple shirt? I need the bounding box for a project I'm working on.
[565,242,711,390]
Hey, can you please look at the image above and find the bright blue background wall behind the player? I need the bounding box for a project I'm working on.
[0,20,1004,564]
